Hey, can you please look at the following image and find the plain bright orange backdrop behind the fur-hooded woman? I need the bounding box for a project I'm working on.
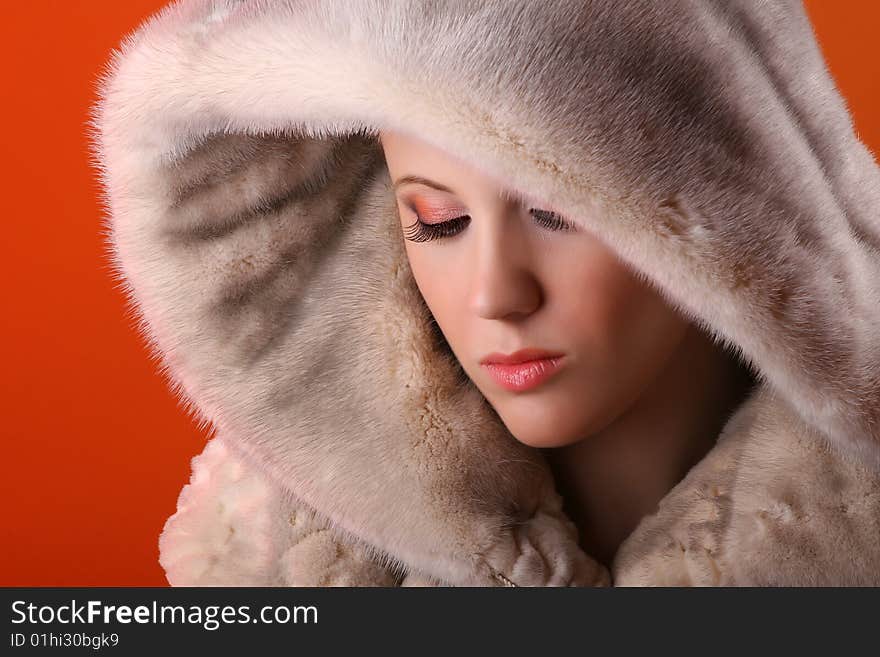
[0,0,880,586]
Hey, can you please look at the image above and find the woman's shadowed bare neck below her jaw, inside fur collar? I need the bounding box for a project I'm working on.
[542,325,753,567]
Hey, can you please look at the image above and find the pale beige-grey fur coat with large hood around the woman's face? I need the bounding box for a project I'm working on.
[90,0,880,586]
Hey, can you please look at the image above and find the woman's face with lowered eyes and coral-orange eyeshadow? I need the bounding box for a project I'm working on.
[380,132,688,447]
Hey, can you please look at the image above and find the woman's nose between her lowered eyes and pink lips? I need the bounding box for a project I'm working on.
[468,222,543,319]
